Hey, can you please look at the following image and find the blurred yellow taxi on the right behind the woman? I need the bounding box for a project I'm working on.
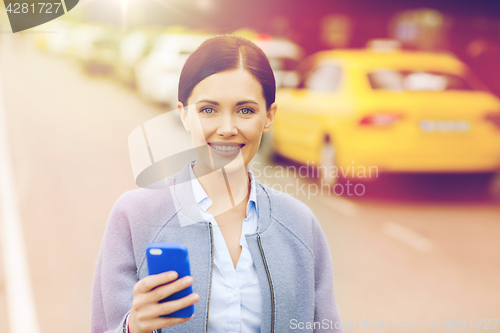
[272,40,500,184]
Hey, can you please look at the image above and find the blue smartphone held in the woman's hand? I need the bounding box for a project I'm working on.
[146,243,194,318]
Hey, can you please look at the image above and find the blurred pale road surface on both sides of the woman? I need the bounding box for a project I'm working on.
[0,34,500,333]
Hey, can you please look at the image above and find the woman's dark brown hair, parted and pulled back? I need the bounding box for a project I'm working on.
[178,35,276,110]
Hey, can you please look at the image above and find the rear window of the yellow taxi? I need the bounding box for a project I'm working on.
[368,69,487,91]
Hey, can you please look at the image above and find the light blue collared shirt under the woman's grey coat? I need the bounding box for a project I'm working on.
[189,164,262,333]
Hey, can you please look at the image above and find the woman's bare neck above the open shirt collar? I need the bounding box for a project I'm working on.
[193,162,251,216]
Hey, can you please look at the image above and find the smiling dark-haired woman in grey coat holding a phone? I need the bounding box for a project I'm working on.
[92,35,342,333]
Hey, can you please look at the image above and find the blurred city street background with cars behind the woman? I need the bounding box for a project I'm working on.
[0,0,500,333]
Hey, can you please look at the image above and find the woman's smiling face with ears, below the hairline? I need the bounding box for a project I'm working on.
[178,68,276,172]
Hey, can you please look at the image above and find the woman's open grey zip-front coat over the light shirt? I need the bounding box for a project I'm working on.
[91,162,342,333]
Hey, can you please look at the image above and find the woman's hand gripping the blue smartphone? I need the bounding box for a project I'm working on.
[128,271,200,333]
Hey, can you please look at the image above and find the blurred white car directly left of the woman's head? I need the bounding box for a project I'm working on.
[135,32,210,108]
